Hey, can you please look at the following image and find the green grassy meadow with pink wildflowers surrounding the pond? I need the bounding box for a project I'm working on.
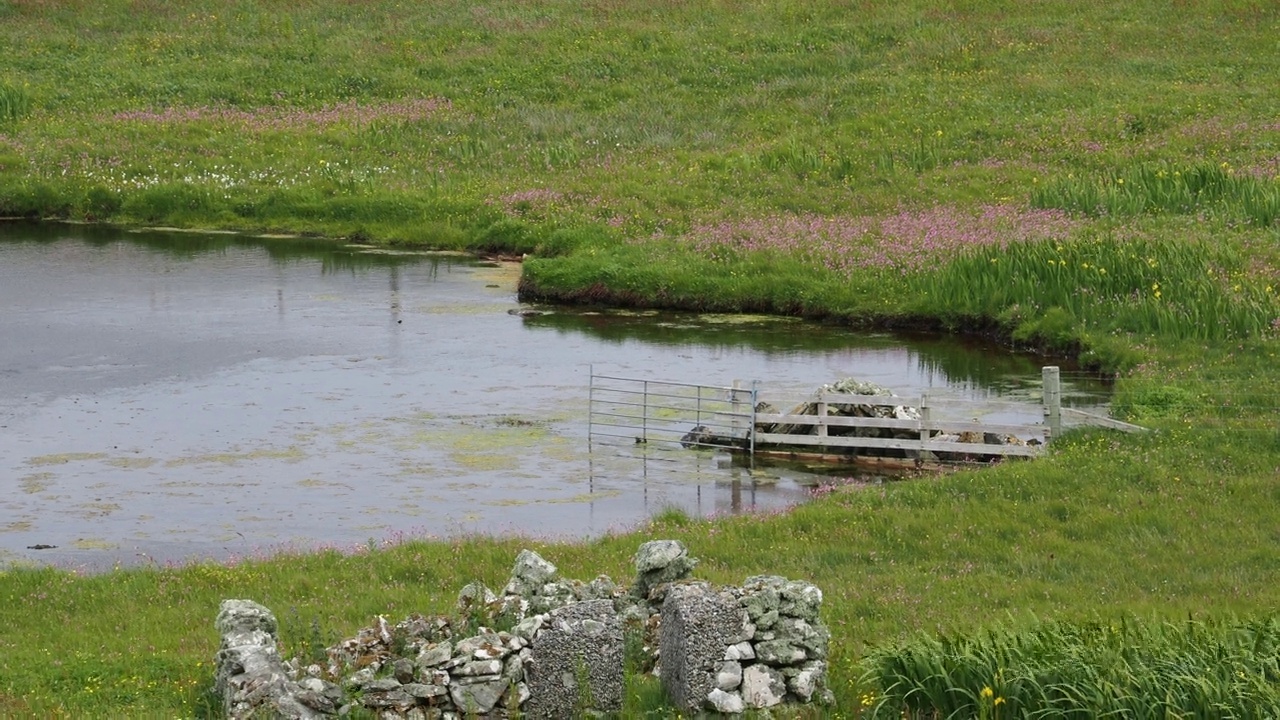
[0,0,1280,717]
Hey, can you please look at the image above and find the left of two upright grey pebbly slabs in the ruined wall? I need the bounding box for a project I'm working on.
[521,600,623,720]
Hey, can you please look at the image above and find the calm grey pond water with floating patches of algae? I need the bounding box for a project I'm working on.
[0,224,1107,568]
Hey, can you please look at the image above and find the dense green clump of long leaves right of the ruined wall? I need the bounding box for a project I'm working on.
[864,609,1280,720]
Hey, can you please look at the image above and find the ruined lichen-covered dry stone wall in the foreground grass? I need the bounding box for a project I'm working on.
[215,541,831,720]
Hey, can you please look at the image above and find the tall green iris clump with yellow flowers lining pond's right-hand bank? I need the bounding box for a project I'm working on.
[908,231,1280,341]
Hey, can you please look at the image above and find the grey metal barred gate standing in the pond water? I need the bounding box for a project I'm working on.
[588,370,755,452]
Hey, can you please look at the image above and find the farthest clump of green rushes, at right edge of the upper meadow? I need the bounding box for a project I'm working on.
[1032,161,1280,227]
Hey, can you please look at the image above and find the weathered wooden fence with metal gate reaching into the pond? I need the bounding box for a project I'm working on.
[589,366,1142,459]
